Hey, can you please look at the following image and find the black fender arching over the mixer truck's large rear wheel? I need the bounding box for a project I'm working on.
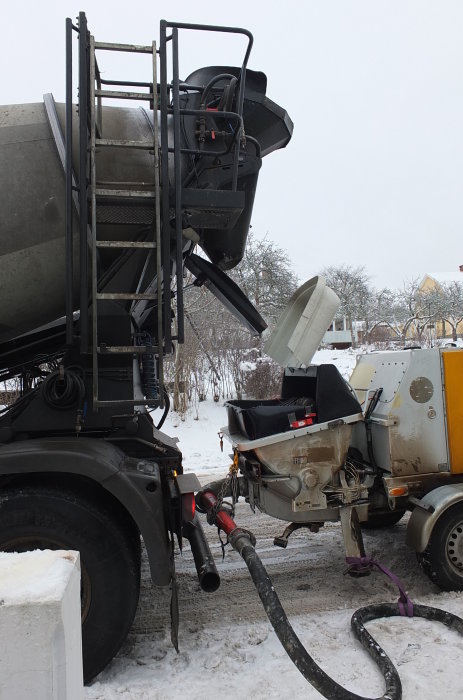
[0,437,171,586]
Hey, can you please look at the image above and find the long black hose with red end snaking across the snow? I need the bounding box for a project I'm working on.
[197,487,463,700]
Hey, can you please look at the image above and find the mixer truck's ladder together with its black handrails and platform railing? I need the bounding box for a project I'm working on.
[66,12,252,410]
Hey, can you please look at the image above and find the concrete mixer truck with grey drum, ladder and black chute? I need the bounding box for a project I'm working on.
[0,13,292,681]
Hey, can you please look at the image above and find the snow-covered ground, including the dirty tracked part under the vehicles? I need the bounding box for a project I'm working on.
[85,350,463,700]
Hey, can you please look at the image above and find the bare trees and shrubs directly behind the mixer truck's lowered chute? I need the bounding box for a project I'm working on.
[169,234,297,413]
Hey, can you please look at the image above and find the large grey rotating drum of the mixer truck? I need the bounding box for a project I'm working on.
[0,103,159,342]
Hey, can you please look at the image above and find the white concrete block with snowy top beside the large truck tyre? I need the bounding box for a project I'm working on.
[0,550,84,700]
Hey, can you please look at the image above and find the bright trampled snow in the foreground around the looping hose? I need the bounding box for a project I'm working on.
[86,601,463,700]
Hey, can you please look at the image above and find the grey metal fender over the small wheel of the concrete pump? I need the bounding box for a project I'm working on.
[407,484,463,553]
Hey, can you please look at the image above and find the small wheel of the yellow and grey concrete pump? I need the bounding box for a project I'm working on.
[418,503,463,591]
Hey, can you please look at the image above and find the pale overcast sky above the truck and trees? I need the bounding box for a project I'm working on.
[0,0,463,288]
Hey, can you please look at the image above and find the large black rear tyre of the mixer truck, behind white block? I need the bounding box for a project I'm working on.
[0,487,140,683]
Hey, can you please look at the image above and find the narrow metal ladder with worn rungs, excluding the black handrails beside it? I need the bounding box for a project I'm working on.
[89,36,163,408]
